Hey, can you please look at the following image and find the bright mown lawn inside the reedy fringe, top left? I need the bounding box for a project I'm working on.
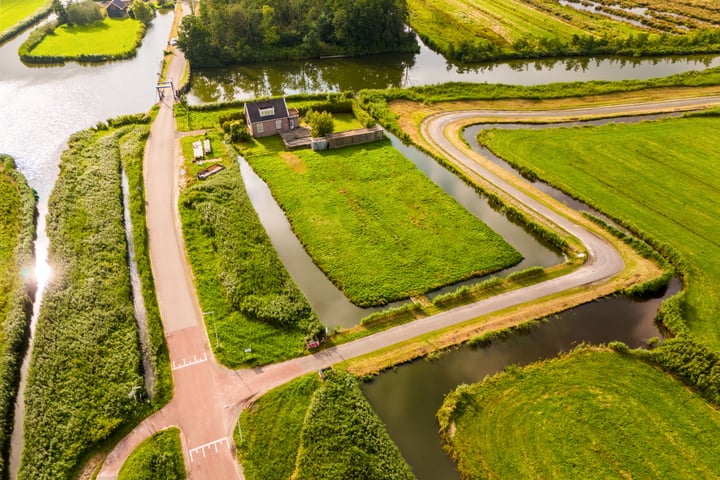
[29,18,143,58]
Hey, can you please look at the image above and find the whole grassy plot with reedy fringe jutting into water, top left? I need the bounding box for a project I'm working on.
[19,18,146,63]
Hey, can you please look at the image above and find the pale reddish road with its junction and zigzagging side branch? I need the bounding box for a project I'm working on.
[97,31,720,480]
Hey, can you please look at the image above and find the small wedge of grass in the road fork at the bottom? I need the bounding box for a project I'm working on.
[118,427,186,480]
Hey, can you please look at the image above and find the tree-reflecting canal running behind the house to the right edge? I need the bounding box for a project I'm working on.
[188,39,720,104]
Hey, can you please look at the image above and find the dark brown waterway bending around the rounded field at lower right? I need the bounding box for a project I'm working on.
[362,280,680,480]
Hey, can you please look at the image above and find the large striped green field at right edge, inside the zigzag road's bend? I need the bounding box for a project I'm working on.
[483,116,720,348]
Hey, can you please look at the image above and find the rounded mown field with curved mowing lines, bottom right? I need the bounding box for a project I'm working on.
[438,349,720,480]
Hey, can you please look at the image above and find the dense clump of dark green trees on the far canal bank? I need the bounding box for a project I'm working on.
[179,0,417,67]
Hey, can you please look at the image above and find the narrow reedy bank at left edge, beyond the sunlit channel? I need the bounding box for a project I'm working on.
[0,155,36,478]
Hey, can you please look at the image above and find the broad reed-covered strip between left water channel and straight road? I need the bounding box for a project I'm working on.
[18,121,171,479]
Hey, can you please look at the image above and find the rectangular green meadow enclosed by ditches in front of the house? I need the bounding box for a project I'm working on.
[248,141,521,306]
